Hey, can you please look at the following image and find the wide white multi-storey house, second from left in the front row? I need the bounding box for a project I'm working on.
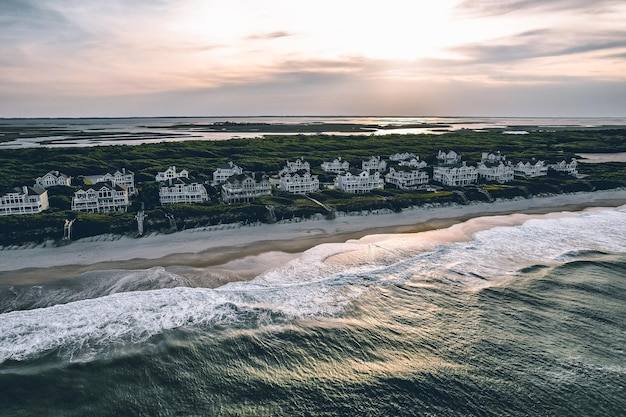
[72,182,130,213]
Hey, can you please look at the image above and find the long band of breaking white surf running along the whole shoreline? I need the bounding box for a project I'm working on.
[0,206,626,363]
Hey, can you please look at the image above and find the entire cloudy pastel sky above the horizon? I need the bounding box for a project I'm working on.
[0,0,626,117]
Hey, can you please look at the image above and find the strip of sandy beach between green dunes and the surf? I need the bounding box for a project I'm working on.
[0,190,626,285]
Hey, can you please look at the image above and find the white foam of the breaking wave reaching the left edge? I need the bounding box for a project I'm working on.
[0,266,362,363]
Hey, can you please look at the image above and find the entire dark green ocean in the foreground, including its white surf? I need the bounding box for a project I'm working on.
[0,207,626,416]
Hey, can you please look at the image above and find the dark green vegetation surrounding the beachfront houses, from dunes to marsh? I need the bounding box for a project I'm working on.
[0,129,626,245]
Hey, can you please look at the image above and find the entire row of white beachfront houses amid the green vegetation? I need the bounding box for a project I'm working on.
[0,151,578,215]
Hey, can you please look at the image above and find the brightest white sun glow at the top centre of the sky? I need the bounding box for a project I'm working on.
[172,0,468,60]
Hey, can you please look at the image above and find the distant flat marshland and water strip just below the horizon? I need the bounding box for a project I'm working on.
[0,116,626,149]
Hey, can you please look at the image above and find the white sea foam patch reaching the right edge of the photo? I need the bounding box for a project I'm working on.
[394,206,626,285]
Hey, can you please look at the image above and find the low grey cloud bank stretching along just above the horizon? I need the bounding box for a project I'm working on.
[0,73,626,117]
